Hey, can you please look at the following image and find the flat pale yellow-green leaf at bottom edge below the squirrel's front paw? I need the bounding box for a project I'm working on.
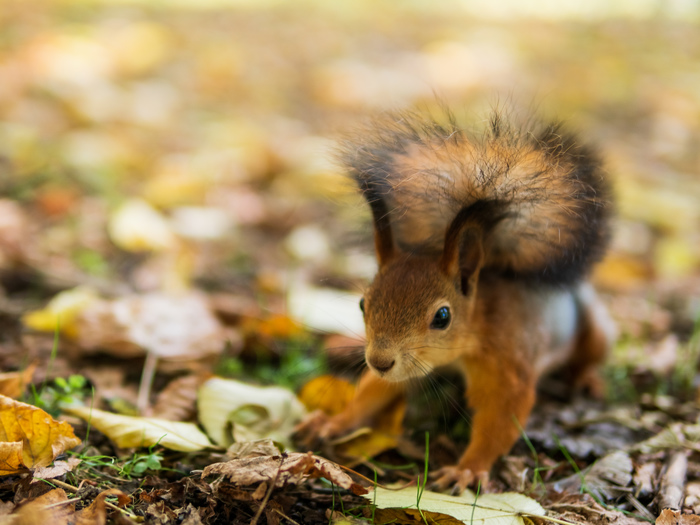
[364,487,546,525]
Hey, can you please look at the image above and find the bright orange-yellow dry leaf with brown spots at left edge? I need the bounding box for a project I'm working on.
[0,396,80,475]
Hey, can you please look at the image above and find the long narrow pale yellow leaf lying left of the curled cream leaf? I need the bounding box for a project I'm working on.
[65,407,213,452]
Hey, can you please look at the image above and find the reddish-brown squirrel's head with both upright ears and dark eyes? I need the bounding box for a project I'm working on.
[360,196,485,381]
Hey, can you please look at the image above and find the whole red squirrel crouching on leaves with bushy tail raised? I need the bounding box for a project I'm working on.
[300,109,614,492]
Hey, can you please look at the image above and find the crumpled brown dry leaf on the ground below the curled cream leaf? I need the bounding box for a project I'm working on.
[202,452,367,495]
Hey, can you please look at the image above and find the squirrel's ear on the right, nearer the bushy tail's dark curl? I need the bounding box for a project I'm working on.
[440,207,485,295]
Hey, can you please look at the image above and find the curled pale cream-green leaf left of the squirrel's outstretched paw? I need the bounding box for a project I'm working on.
[197,377,305,446]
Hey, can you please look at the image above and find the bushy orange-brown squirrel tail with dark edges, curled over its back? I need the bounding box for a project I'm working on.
[341,108,612,284]
